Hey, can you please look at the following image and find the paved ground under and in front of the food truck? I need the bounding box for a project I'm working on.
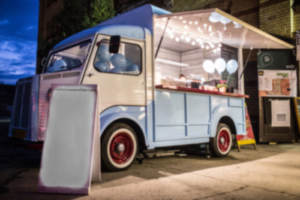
[0,124,300,200]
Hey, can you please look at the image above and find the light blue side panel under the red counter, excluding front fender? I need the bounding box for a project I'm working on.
[153,90,246,147]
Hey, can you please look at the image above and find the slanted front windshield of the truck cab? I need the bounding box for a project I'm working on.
[46,41,91,72]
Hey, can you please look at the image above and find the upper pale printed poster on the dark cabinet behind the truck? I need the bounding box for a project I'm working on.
[258,70,297,97]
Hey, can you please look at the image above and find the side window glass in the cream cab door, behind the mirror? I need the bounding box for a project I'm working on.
[94,40,142,75]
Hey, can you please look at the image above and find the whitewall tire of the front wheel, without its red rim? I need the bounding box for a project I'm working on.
[101,123,139,171]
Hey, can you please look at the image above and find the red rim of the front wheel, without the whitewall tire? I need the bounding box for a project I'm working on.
[110,132,134,164]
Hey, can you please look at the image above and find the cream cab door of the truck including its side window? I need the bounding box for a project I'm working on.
[82,35,146,112]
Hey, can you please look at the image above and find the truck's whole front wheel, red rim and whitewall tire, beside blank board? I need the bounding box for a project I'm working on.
[101,123,138,171]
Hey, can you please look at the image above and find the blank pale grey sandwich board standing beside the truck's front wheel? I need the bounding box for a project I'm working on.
[38,85,100,194]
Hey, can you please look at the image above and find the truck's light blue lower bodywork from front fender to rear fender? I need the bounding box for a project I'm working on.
[100,90,246,149]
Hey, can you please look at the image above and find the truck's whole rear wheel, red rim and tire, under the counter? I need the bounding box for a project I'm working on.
[210,123,232,157]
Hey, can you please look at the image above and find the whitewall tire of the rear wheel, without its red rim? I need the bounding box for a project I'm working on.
[210,123,232,157]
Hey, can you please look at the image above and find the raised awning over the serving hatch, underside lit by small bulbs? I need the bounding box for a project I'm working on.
[154,9,294,49]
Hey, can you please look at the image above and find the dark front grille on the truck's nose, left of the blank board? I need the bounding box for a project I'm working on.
[13,79,32,129]
